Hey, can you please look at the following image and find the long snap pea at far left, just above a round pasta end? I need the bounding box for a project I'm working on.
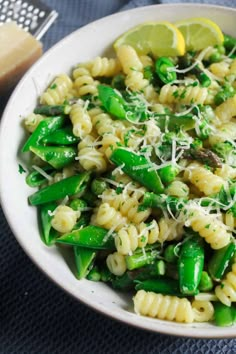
[29,173,90,205]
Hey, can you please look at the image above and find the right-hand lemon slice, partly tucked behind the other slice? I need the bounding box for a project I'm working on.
[175,17,224,50]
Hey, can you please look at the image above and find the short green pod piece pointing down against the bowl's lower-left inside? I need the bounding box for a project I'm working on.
[73,246,97,279]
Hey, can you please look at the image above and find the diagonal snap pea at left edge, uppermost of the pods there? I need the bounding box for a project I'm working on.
[21,116,65,152]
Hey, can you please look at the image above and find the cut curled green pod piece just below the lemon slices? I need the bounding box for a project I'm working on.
[155,57,177,84]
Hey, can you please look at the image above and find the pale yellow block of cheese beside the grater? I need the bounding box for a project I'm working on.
[0,22,42,95]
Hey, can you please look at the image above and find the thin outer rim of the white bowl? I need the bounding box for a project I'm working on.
[0,3,236,339]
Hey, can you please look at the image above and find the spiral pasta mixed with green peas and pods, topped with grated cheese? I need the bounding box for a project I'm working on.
[22,17,236,323]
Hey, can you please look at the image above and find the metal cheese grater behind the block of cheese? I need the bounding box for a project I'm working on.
[0,0,58,40]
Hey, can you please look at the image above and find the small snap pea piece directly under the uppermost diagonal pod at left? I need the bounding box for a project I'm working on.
[42,125,79,145]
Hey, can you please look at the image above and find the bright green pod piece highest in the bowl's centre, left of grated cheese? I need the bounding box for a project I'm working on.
[98,85,126,119]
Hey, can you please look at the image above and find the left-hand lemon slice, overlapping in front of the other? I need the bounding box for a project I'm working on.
[114,21,185,57]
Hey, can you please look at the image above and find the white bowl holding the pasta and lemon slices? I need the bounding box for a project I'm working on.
[0,4,236,338]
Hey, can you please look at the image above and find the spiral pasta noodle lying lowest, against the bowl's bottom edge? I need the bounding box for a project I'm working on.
[133,290,194,323]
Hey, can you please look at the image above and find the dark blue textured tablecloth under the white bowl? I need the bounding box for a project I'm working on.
[0,0,236,354]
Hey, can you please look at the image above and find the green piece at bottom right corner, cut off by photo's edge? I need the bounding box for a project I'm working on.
[214,302,236,327]
